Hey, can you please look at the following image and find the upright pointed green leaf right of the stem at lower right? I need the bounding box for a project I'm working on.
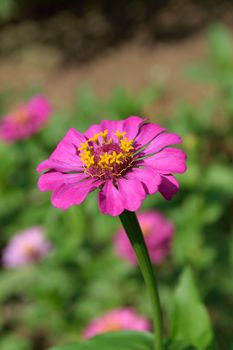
[171,268,213,350]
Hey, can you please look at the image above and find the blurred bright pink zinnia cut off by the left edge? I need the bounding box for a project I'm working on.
[0,96,52,142]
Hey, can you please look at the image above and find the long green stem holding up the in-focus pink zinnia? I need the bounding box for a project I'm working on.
[120,210,163,350]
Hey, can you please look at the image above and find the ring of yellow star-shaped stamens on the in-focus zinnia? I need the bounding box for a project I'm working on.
[78,130,134,171]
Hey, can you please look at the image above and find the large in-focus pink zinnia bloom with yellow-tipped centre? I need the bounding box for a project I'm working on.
[37,117,186,216]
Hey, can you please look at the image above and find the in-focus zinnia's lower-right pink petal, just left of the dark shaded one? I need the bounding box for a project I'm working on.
[127,167,161,194]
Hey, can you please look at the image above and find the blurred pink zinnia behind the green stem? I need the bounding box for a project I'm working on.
[115,211,174,265]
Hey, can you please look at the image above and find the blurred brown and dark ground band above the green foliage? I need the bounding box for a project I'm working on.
[0,0,233,114]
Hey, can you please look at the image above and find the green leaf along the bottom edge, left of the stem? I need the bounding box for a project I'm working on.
[51,331,153,350]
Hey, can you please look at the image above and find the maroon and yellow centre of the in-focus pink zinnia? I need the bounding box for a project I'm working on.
[78,130,134,179]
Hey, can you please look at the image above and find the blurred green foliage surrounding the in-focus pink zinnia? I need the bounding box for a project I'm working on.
[0,0,233,350]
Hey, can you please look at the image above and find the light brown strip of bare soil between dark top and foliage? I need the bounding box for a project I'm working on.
[0,32,208,113]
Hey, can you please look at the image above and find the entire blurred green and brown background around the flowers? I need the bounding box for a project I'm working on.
[0,0,233,350]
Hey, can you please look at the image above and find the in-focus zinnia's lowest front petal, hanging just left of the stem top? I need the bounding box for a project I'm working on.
[98,181,125,216]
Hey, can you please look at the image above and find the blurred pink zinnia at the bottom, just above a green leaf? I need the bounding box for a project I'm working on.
[83,309,150,339]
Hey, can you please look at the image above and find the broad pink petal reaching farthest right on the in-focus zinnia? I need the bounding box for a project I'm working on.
[143,148,186,174]
